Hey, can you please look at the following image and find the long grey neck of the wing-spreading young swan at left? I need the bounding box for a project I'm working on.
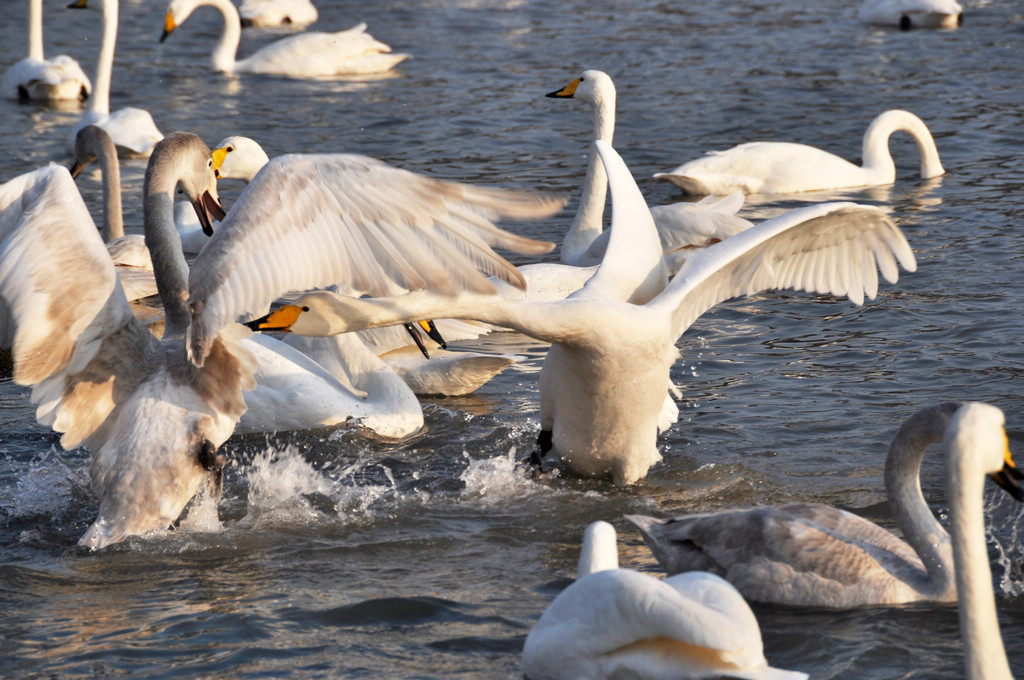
[142,155,190,338]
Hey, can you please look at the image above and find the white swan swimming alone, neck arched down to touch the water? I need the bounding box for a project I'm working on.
[654,109,945,195]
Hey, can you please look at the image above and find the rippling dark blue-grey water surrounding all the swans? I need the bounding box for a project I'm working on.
[0,0,1024,678]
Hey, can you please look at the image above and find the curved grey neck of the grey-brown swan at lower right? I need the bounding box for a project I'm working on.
[885,403,959,597]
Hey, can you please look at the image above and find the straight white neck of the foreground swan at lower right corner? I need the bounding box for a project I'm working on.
[946,438,1013,680]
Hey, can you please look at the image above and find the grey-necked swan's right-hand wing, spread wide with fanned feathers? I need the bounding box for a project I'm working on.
[189,154,565,364]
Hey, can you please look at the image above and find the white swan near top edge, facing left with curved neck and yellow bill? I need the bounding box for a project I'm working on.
[160,0,409,78]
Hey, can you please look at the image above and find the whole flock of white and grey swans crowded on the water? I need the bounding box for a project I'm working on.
[0,0,1011,680]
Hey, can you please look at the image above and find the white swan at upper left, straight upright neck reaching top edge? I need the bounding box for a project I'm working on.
[67,0,164,157]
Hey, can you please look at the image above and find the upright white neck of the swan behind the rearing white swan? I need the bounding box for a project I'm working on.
[561,91,615,263]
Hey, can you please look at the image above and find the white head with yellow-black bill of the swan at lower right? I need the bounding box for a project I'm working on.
[943,402,1024,502]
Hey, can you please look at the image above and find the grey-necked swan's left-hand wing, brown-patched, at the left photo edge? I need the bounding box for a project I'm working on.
[0,165,156,449]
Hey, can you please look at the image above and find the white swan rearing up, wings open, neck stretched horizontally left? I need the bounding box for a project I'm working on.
[243,139,915,485]
